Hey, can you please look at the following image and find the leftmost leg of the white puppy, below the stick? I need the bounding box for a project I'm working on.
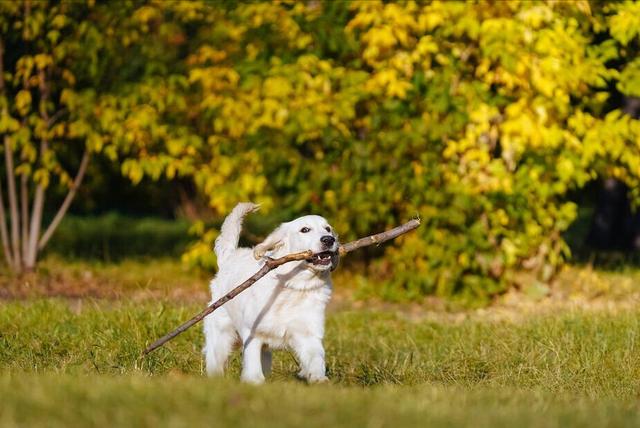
[202,309,237,376]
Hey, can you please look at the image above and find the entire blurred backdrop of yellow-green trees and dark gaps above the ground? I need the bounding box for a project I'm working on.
[0,0,640,303]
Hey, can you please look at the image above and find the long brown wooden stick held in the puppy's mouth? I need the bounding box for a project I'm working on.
[142,219,420,357]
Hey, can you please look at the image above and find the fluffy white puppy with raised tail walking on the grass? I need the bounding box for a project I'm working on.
[203,202,338,383]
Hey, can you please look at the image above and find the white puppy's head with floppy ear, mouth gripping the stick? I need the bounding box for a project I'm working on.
[253,215,339,271]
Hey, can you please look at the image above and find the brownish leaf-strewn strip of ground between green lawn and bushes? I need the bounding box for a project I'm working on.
[0,257,640,322]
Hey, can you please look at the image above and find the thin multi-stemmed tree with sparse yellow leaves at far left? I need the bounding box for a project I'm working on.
[0,0,126,273]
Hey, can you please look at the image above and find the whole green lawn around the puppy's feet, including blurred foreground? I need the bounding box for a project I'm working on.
[0,299,640,427]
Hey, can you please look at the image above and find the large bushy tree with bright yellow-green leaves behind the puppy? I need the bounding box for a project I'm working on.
[92,1,640,300]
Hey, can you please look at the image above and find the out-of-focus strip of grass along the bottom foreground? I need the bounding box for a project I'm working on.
[5,375,640,428]
